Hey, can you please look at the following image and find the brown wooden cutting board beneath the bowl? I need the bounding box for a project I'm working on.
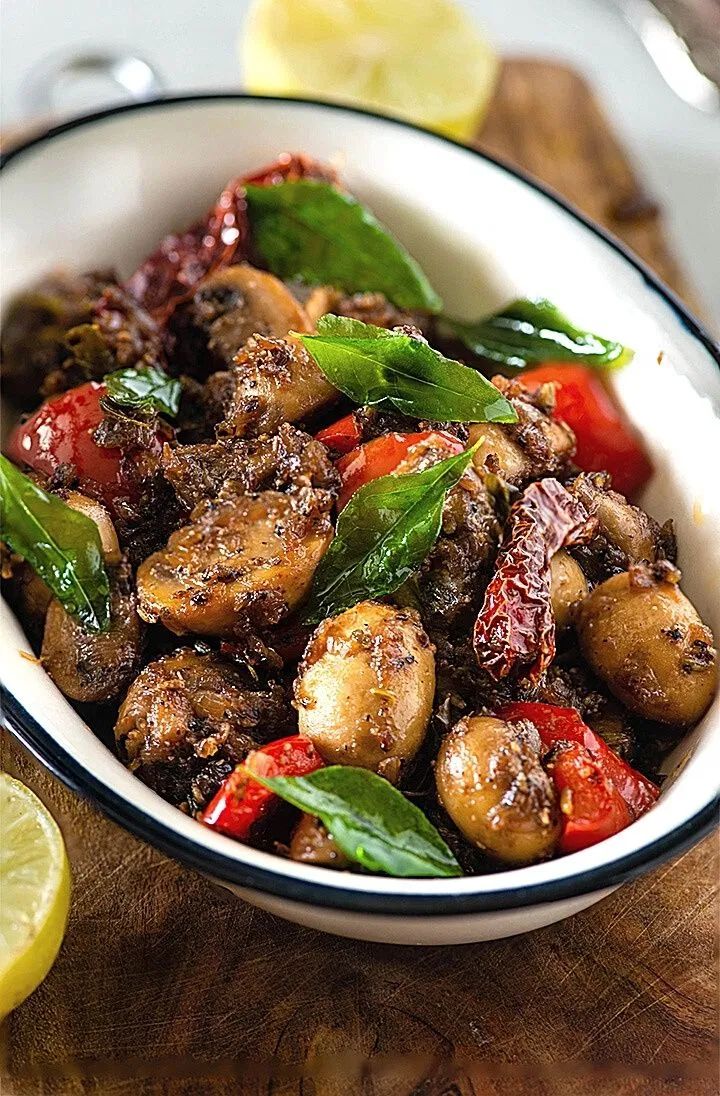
[2,60,719,1096]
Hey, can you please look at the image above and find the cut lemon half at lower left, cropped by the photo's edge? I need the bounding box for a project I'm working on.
[0,773,70,1019]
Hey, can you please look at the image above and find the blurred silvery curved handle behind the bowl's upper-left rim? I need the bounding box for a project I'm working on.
[21,49,164,119]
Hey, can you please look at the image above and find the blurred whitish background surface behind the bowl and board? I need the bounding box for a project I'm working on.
[0,0,720,332]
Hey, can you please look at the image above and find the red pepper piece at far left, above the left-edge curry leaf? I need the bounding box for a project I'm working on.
[7,380,162,504]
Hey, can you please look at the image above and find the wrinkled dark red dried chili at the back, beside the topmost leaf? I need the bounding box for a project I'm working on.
[125,153,335,322]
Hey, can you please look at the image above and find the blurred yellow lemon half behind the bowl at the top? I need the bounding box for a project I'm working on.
[241,0,499,140]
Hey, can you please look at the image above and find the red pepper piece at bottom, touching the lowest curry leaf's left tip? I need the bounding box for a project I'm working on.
[201,734,323,841]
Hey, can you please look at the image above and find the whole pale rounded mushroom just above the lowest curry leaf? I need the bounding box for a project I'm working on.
[295,602,435,778]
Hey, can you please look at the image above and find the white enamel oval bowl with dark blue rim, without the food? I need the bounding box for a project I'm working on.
[1,95,720,944]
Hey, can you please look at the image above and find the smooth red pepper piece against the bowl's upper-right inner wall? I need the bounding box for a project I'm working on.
[516,362,652,496]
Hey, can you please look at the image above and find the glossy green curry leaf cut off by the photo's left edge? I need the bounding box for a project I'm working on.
[0,456,110,631]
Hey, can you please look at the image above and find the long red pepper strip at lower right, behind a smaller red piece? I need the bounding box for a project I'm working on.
[500,700,660,818]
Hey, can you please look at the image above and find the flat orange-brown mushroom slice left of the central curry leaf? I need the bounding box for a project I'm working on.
[137,488,332,636]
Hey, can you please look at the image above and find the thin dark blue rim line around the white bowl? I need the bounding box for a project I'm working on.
[0,92,720,916]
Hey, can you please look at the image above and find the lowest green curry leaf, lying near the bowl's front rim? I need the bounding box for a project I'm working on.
[250,765,462,878]
